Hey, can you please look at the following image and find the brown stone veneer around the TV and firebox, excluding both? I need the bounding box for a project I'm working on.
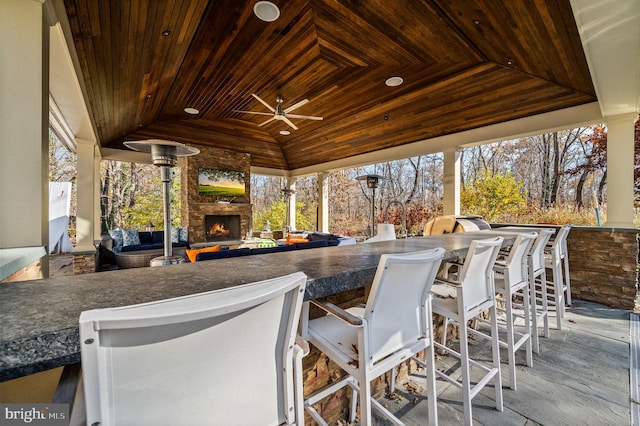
[179,147,253,244]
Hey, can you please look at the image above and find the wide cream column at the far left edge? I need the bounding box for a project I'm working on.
[0,0,49,277]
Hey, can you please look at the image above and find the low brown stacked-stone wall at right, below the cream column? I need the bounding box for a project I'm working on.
[568,227,638,310]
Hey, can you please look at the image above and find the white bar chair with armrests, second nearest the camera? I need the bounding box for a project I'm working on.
[302,248,445,426]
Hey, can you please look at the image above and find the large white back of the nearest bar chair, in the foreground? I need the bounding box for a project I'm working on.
[80,272,306,426]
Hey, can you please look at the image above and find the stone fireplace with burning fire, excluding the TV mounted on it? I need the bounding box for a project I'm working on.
[179,147,253,244]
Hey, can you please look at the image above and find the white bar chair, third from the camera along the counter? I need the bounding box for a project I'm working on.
[432,237,504,425]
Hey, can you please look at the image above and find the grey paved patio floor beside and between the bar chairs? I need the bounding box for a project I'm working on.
[377,300,638,426]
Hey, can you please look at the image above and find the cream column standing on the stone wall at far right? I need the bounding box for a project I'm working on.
[605,113,638,228]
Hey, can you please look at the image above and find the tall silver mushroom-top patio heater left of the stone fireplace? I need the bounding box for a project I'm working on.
[124,139,200,266]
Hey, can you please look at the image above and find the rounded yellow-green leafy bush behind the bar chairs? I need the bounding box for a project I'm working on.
[460,169,526,221]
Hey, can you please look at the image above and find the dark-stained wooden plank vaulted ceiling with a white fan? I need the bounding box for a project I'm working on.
[64,0,596,170]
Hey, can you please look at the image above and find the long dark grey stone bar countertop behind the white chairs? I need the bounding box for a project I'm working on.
[0,231,515,382]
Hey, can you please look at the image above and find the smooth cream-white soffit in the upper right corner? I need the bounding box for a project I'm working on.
[571,0,640,117]
